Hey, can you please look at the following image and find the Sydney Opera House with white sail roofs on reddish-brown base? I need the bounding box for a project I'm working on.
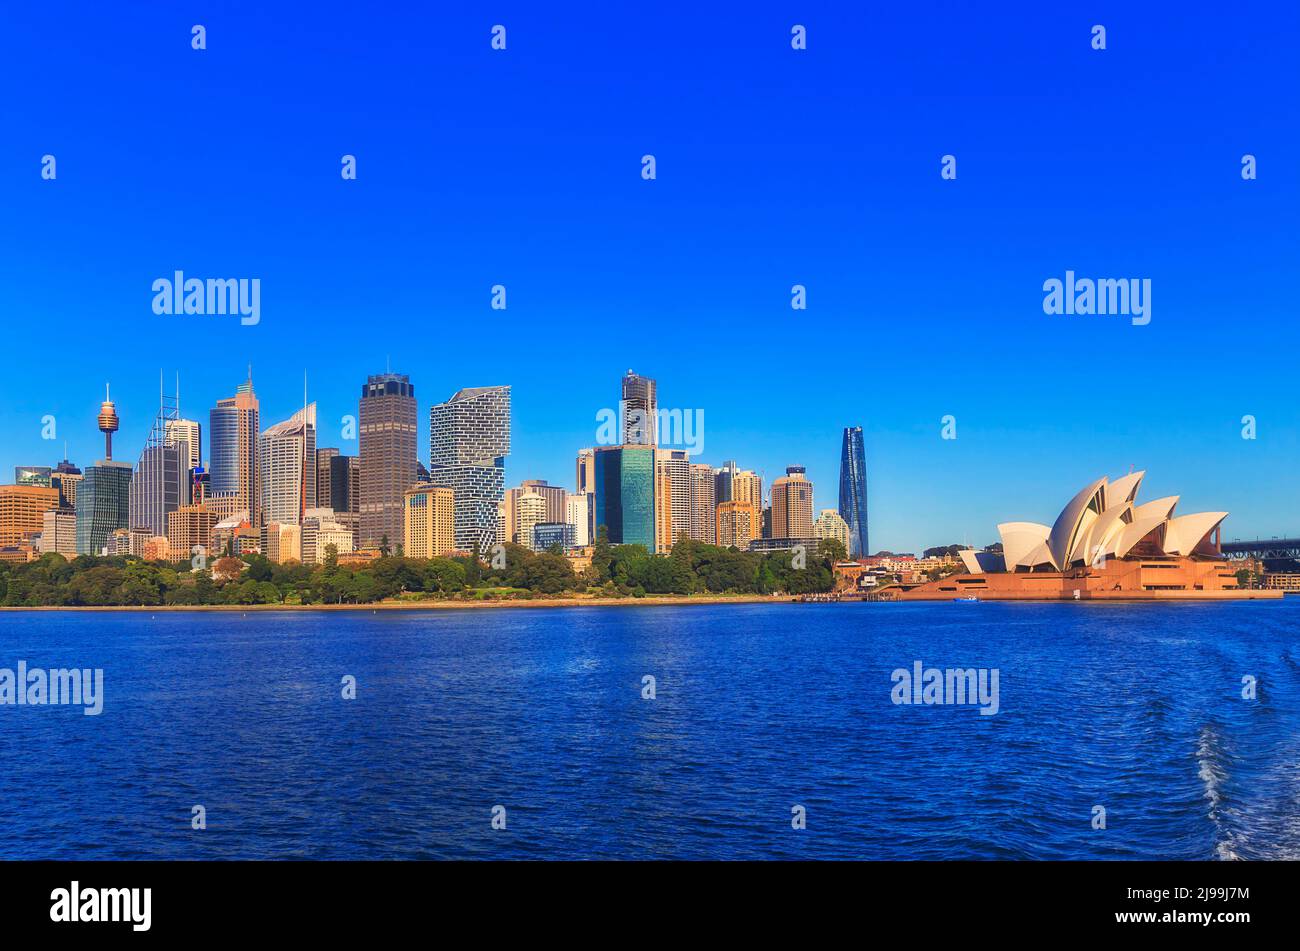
[901,472,1282,600]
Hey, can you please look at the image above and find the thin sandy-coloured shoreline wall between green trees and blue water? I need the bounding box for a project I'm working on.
[0,595,797,613]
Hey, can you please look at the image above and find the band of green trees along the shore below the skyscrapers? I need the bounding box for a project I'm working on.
[0,534,844,608]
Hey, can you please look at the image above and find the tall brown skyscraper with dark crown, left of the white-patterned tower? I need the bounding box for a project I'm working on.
[358,373,419,550]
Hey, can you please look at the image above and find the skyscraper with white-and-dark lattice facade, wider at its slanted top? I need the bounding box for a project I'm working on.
[426,386,510,553]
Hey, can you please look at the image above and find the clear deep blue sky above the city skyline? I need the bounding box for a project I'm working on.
[0,3,1300,550]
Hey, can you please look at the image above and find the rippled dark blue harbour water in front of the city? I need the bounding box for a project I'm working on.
[0,599,1300,859]
